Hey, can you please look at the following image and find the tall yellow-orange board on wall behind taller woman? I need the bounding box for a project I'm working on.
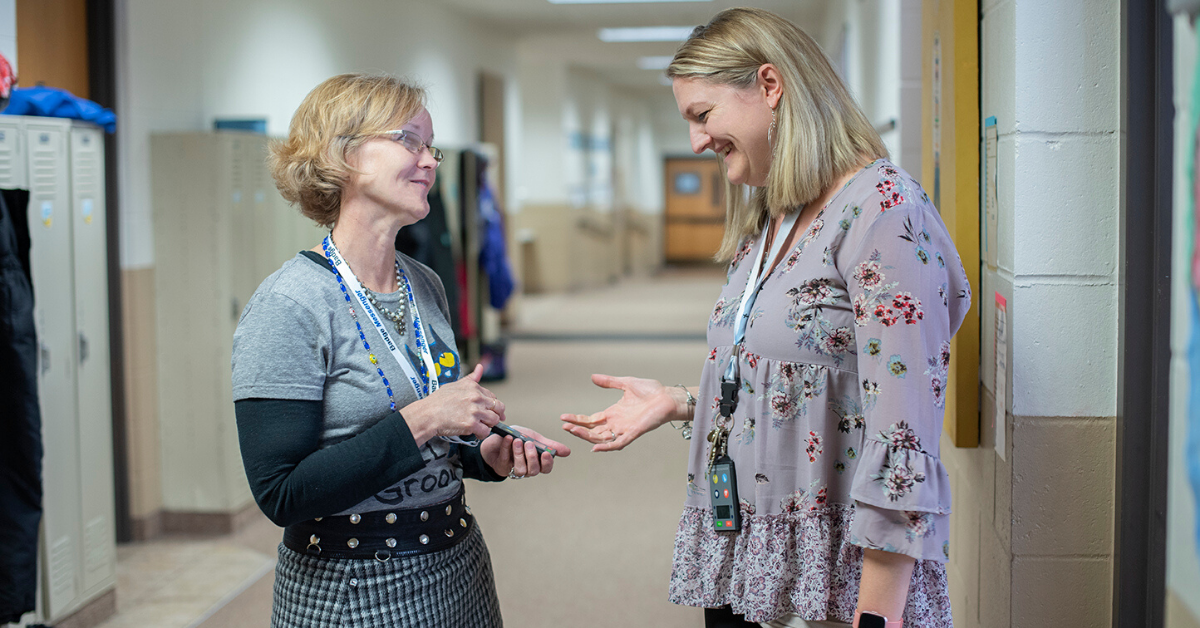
[920,0,985,447]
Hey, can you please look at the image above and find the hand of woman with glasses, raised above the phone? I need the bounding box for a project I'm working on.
[401,365,504,447]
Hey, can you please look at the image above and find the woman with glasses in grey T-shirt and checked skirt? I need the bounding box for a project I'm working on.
[233,74,570,628]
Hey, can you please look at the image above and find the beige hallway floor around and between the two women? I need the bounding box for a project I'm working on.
[93,268,725,628]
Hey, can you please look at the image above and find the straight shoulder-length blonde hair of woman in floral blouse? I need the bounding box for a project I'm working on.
[667,8,888,261]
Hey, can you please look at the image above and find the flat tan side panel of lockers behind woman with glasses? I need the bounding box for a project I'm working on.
[150,133,251,513]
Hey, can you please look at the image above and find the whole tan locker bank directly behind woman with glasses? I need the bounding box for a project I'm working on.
[151,132,320,514]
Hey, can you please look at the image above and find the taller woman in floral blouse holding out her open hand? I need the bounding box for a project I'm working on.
[563,8,971,628]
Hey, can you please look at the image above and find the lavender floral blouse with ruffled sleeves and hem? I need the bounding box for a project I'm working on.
[670,160,971,628]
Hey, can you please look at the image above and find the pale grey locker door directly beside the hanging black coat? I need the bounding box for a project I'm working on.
[25,120,80,618]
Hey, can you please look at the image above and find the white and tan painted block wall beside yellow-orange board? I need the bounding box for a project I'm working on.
[942,0,1123,628]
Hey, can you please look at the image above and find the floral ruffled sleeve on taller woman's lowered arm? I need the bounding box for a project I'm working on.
[839,202,971,562]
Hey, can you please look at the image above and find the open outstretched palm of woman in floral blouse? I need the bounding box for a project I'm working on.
[562,375,691,451]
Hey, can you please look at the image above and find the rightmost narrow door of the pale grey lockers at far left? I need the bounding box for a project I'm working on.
[71,126,116,596]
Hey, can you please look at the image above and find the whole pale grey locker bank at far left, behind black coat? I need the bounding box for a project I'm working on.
[0,116,116,621]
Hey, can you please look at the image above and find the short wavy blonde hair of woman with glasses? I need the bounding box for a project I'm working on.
[268,73,425,228]
